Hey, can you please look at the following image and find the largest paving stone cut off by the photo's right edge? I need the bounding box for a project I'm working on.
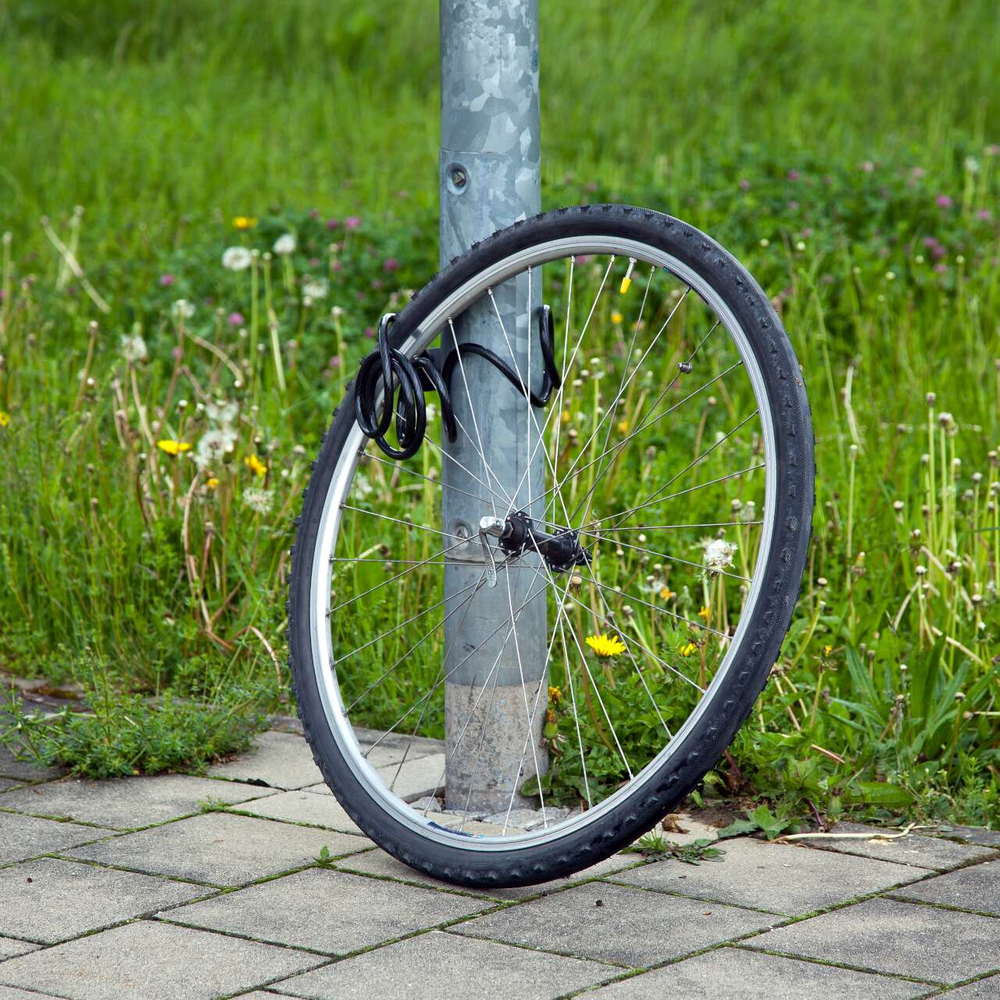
[748,899,1000,983]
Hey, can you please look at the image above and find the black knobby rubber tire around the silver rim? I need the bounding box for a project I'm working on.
[288,205,814,887]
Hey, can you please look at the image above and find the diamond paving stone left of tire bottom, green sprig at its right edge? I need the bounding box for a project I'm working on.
[68,813,372,885]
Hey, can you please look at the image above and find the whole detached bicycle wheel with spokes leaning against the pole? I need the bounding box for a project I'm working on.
[289,205,813,886]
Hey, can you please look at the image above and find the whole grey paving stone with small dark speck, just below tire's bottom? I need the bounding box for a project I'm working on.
[454,882,780,966]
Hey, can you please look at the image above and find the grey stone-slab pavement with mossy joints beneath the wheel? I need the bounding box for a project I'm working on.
[0,732,1000,1000]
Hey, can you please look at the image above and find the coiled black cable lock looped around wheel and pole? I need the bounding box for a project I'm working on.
[354,305,562,459]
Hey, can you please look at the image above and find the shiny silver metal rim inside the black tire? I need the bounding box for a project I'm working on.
[309,236,777,853]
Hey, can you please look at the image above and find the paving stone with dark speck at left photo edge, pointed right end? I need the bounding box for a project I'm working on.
[0,858,205,944]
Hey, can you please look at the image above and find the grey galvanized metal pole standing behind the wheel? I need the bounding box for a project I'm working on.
[440,0,548,813]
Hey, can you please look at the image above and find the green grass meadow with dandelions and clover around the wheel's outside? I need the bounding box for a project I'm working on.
[0,0,1000,822]
